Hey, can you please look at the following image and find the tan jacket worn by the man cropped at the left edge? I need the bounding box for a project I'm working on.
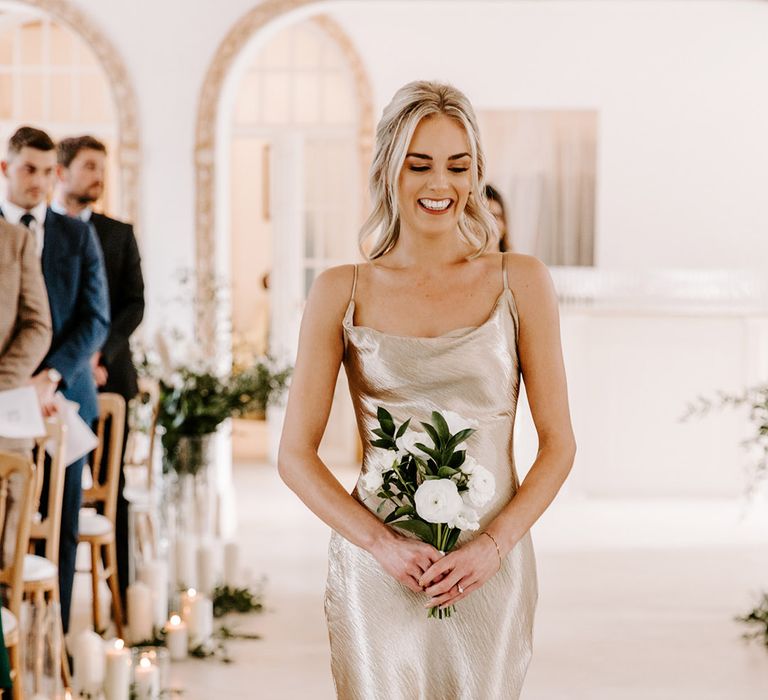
[0,218,51,430]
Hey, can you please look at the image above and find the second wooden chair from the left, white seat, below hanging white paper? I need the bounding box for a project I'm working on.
[23,418,72,687]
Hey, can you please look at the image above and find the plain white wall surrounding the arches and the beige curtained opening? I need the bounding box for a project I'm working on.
[64,0,768,332]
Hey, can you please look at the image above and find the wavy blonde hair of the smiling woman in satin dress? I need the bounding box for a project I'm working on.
[360,80,498,260]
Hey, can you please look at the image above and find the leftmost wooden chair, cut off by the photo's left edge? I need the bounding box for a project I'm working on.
[0,451,34,700]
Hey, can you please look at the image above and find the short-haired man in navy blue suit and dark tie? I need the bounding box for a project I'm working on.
[0,126,110,632]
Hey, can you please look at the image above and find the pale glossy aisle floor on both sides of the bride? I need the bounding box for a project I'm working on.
[70,464,768,700]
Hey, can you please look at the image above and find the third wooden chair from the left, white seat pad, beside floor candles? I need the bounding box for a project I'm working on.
[79,393,125,639]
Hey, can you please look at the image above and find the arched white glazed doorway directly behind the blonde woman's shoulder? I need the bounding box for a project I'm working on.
[197,3,373,470]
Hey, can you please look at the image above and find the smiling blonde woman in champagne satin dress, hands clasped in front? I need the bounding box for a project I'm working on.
[279,82,575,700]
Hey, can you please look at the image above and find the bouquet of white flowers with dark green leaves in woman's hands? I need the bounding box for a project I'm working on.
[362,407,496,619]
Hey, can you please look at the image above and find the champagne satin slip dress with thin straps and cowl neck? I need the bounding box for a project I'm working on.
[325,256,537,700]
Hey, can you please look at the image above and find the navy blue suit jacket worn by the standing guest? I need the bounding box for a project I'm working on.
[40,209,110,424]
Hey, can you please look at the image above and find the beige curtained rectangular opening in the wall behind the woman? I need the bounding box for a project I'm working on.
[478,110,597,265]
